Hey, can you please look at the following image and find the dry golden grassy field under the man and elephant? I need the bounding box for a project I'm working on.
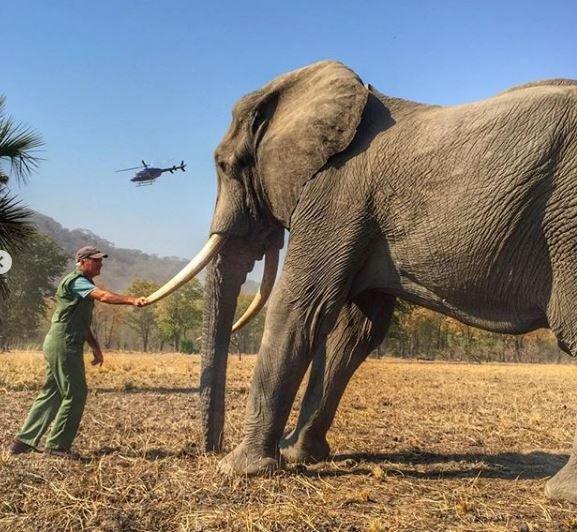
[0,353,577,532]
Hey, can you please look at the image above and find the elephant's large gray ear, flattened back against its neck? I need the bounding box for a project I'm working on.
[253,61,368,227]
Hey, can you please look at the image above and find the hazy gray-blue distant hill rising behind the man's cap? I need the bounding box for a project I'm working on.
[32,212,258,294]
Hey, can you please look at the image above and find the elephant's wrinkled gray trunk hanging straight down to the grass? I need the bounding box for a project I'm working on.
[200,243,254,451]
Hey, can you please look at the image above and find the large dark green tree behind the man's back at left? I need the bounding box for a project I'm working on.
[0,232,67,345]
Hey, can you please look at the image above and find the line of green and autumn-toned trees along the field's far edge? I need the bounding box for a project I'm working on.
[0,232,570,362]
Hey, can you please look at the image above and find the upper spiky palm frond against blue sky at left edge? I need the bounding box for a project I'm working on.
[0,96,44,185]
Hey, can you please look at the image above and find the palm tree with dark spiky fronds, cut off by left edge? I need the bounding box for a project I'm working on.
[0,96,43,302]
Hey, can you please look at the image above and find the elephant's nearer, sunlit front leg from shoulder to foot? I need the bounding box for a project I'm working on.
[220,208,370,474]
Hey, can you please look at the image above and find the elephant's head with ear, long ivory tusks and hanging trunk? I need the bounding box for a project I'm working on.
[149,61,368,450]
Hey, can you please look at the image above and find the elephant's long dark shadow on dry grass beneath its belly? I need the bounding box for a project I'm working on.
[305,451,569,480]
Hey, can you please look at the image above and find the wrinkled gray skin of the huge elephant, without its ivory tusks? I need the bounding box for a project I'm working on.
[201,61,577,500]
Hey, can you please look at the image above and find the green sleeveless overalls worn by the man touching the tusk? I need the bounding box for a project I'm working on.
[16,270,94,450]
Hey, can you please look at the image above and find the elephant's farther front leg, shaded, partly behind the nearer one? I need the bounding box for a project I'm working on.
[281,291,395,462]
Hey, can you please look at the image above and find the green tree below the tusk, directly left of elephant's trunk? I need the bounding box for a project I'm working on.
[156,279,202,351]
